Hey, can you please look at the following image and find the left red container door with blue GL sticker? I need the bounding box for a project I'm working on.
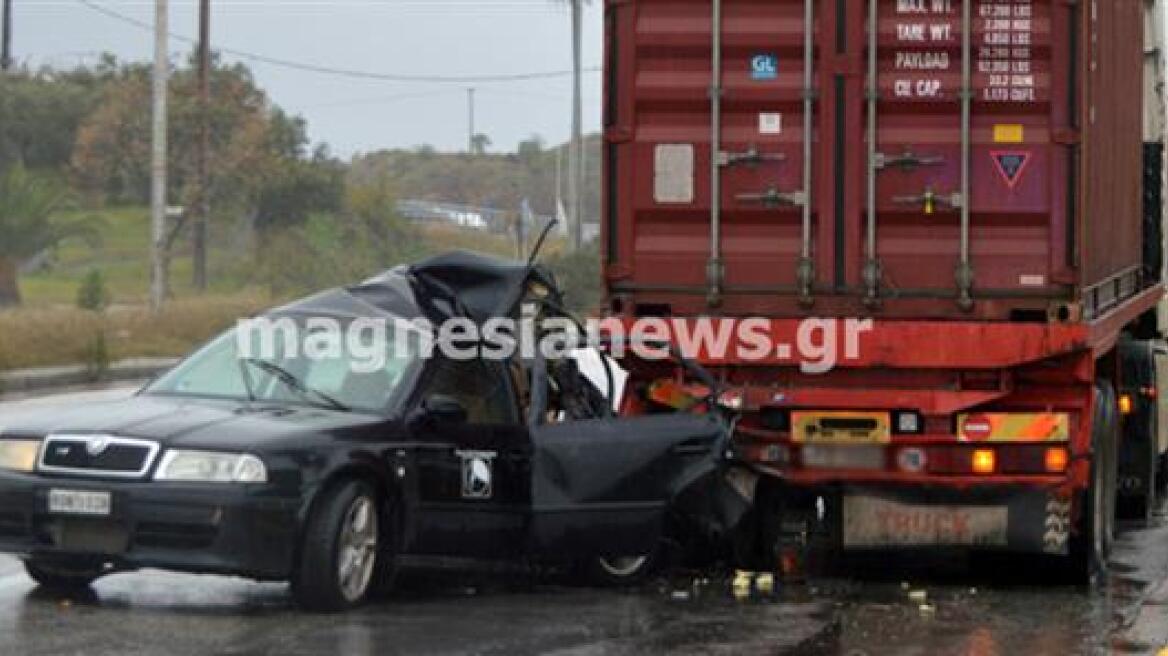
[606,0,818,310]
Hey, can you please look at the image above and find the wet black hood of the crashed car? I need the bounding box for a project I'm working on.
[0,395,384,448]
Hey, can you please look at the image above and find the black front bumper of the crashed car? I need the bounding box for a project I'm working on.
[0,472,300,580]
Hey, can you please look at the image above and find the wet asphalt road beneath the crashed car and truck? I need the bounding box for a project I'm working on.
[0,390,1168,656]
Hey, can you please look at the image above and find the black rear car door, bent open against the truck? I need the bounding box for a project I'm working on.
[528,352,724,556]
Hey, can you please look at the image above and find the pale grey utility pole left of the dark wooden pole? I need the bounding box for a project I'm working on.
[150,0,171,312]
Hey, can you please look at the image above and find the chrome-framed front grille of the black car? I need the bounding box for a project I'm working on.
[40,435,159,477]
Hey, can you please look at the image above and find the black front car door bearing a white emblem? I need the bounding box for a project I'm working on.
[411,360,530,557]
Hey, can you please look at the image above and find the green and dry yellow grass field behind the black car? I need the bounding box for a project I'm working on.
[0,208,530,370]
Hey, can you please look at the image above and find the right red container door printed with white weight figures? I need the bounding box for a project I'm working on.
[864,0,1073,312]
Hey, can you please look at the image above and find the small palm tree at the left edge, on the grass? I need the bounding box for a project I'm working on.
[0,165,96,307]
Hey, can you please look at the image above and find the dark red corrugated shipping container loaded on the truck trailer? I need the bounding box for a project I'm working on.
[603,0,1148,322]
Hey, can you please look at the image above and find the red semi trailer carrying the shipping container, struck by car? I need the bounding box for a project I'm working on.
[600,0,1168,577]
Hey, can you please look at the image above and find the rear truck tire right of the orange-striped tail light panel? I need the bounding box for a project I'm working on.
[1070,382,1119,584]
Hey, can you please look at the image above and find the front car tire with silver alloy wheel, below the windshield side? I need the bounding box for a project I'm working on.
[292,480,394,613]
